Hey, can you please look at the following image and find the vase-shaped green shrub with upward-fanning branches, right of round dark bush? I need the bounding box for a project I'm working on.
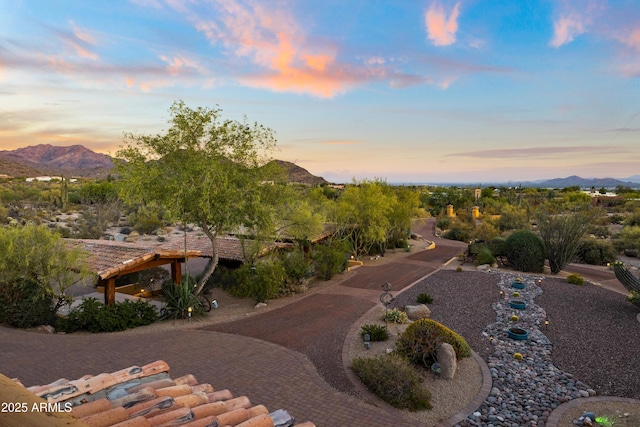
[536,204,599,274]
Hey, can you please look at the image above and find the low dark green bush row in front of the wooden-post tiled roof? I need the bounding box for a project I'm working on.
[56,298,158,333]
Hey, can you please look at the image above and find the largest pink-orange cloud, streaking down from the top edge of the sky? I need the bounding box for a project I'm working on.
[170,0,385,98]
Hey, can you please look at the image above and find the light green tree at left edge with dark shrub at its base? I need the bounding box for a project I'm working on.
[0,225,91,327]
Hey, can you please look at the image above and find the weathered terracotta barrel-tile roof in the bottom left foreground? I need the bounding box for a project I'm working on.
[5,360,315,427]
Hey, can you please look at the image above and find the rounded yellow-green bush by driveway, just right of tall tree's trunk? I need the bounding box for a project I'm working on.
[229,259,286,303]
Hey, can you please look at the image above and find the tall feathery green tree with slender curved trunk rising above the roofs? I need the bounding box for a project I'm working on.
[117,101,277,292]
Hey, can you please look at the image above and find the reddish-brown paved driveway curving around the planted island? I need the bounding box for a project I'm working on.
[0,220,632,427]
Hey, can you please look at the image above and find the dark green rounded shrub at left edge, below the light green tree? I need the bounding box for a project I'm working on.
[0,278,55,328]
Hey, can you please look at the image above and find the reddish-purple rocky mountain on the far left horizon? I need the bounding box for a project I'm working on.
[0,144,113,177]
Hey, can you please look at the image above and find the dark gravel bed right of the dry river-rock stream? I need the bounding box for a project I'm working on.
[536,278,640,399]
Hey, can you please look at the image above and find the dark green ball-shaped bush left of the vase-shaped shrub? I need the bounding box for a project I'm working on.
[504,230,546,273]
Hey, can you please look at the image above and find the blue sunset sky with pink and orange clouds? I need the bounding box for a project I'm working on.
[0,0,640,183]
